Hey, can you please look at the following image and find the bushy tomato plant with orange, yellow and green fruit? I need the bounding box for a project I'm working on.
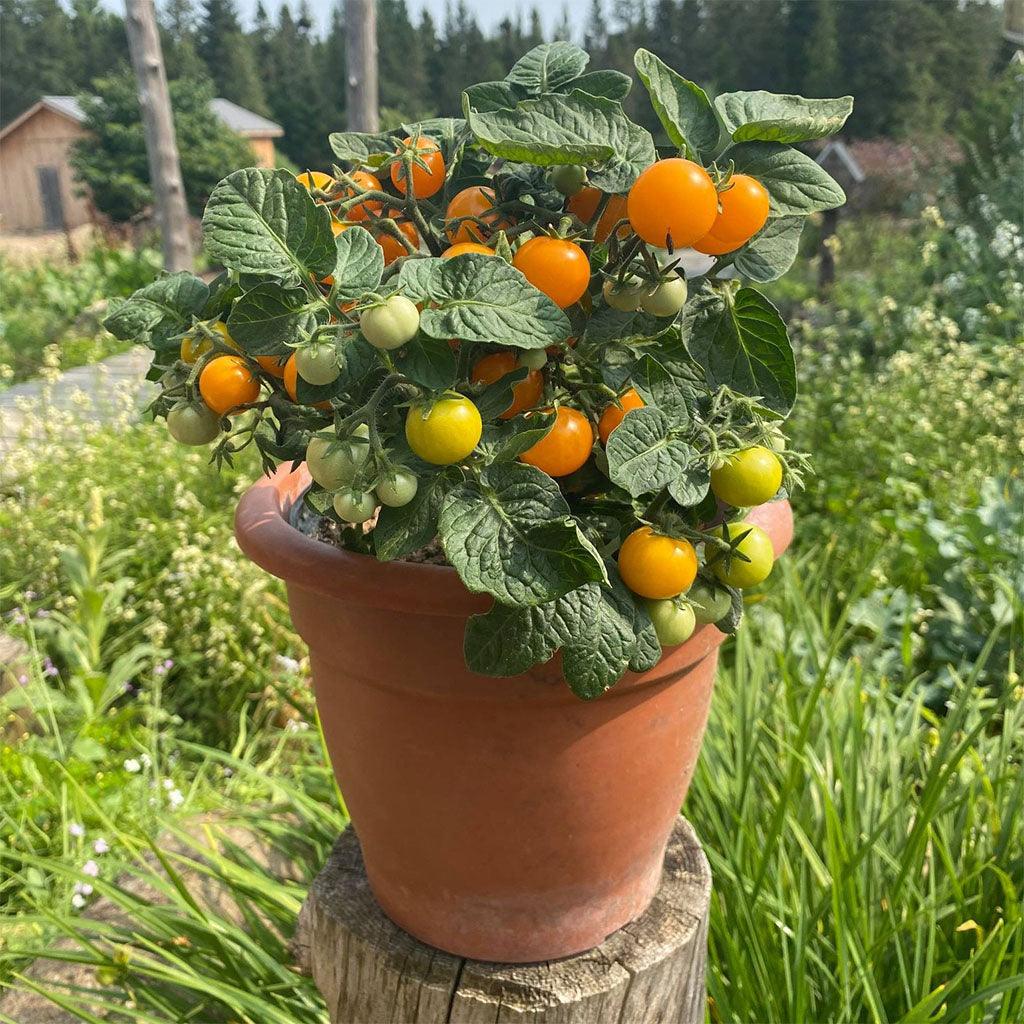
[106,43,852,697]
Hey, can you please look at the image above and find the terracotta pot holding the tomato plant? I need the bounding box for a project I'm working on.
[236,469,793,963]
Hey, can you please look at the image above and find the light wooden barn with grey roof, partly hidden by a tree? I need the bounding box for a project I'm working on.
[0,96,285,231]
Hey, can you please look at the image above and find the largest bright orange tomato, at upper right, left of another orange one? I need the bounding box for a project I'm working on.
[627,157,718,249]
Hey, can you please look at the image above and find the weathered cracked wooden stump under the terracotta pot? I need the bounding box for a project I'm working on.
[295,817,711,1024]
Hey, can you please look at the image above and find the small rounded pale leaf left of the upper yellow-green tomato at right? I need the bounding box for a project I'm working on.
[606,407,697,498]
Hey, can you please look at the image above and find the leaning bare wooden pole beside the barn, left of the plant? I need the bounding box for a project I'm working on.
[125,0,193,270]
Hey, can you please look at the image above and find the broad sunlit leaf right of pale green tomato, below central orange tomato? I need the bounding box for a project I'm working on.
[420,253,571,348]
